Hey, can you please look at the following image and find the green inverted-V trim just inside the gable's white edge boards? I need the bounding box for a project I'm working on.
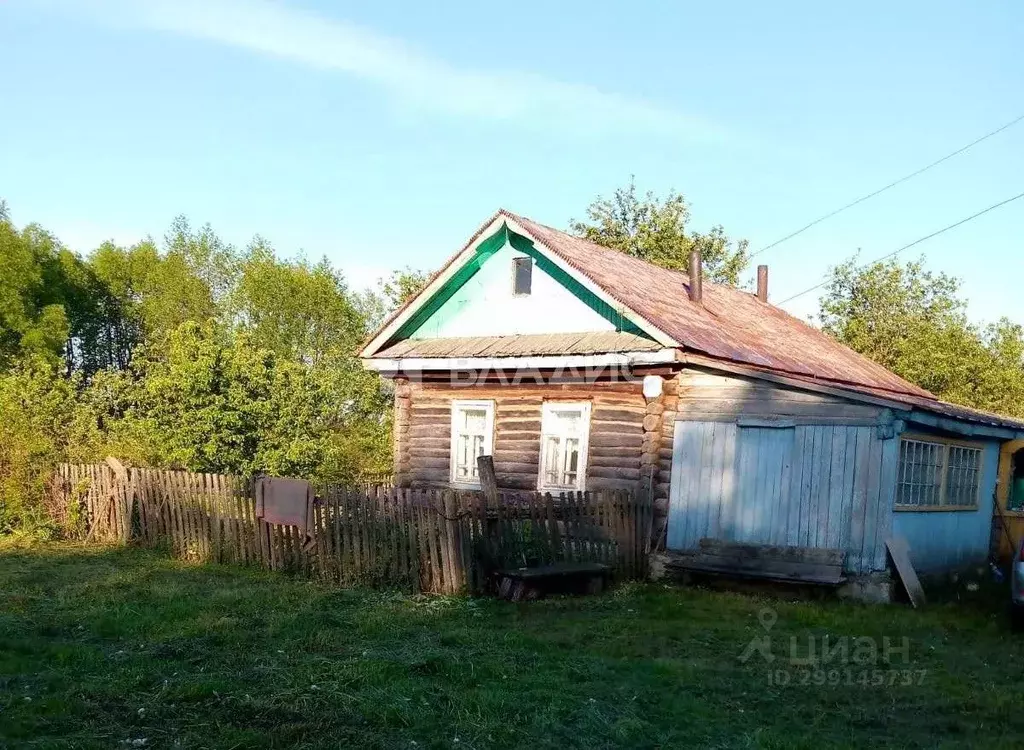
[388,222,653,343]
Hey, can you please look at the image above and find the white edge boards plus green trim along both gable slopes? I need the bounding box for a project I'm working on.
[360,212,680,358]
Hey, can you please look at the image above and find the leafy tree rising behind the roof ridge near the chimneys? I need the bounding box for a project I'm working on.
[569,179,748,286]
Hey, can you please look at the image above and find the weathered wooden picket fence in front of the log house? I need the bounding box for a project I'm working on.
[51,461,653,593]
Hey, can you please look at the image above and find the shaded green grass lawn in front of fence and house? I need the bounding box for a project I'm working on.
[0,545,1024,749]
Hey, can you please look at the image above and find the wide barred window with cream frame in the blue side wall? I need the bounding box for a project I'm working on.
[896,438,981,510]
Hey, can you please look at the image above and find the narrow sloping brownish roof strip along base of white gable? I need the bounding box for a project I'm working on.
[374,331,662,359]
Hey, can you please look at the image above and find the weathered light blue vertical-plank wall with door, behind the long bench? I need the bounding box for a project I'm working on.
[667,420,899,573]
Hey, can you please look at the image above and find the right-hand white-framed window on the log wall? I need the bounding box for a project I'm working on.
[538,401,590,490]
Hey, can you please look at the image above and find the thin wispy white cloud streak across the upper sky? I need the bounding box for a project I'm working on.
[66,0,722,139]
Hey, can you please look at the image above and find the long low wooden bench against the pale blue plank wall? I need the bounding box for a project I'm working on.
[663,539,846,586]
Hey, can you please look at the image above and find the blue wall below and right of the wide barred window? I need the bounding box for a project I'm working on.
[893,442,999,573]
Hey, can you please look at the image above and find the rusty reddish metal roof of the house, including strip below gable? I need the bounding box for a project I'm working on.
[367,209,1024,430]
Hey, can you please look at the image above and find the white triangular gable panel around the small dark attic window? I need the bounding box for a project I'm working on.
[414,244,615,338]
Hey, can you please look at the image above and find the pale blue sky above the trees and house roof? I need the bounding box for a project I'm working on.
[0,0,1024,323]
